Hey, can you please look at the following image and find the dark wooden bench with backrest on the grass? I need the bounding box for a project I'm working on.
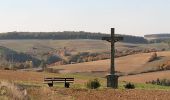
[44,77,74,88]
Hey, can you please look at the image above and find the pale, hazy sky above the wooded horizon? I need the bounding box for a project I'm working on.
[0,0,170,36]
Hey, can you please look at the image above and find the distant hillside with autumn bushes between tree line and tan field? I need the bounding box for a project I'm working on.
[0,39,169,67]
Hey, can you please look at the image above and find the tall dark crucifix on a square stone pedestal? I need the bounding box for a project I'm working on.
[102,28,123,88]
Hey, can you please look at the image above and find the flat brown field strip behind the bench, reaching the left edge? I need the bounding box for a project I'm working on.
[0,70,89,84]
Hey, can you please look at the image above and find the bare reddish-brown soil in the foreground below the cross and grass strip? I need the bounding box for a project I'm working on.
[56,89,170,100]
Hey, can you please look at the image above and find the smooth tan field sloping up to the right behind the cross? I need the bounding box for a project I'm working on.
[50,51,170,73]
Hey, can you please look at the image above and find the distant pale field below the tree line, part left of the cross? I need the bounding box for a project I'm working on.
[0,40,109,52]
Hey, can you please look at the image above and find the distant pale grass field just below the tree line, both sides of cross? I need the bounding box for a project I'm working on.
[0,39,169,52]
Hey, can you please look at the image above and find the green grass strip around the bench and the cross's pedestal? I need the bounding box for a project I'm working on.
[43,73,170,90]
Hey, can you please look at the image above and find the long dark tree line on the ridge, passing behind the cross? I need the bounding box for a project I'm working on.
[0,31,147,43]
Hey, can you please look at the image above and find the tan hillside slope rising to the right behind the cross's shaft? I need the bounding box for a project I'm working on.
[49,51,170,76]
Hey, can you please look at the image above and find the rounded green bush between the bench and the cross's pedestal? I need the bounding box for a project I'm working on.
[86,78,101,89]
